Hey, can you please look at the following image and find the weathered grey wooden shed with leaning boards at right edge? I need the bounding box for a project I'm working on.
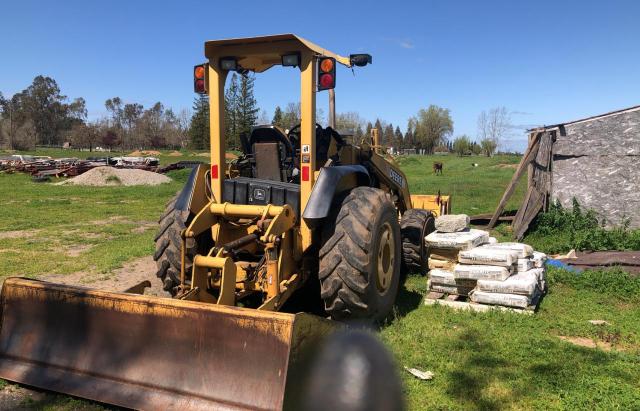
[489,106,640,238]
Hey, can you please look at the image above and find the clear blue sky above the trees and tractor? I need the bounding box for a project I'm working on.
[0,0,640,151]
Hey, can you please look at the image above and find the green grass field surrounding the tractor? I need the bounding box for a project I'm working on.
[0,151,640,410]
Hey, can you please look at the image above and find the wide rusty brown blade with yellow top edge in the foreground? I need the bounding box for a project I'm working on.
[0,278,335,410]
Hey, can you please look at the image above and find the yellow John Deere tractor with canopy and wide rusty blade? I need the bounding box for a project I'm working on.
[0,34,448,410]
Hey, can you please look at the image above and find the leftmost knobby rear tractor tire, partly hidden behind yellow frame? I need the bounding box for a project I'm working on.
[153,194,197,296]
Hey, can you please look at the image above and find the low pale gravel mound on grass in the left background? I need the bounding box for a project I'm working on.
[61,167,171,187]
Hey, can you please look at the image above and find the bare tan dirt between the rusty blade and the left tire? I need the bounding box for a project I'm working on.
[38,256,170,297]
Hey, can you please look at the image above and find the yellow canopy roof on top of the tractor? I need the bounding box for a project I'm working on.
[204,34,351,73]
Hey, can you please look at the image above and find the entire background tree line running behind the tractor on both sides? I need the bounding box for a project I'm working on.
[0,73,511,156]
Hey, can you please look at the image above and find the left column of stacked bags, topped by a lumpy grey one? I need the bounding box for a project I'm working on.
[425,214,489,296]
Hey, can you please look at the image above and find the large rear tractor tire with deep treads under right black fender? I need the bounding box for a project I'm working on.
[318,187,401,322]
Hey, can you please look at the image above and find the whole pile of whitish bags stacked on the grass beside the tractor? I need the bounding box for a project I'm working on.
[425,215,546,310]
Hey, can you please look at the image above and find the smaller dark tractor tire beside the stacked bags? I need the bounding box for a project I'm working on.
[400,208,436,277]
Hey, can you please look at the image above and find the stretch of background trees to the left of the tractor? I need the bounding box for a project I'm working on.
[0,76,190,150]
